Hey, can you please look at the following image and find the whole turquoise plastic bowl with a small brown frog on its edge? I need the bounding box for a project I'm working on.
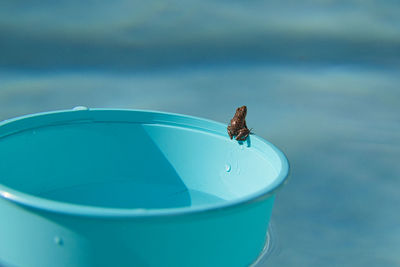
[0,108,289,267]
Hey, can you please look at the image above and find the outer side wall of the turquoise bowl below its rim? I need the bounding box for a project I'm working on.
[0,195,275,267]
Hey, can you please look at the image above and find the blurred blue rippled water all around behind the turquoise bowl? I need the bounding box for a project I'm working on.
[0,0,400,266]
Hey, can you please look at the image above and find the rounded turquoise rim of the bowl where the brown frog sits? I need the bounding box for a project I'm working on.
[0,107,290,218]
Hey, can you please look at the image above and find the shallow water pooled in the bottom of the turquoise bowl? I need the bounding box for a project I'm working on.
[39,182,226,209]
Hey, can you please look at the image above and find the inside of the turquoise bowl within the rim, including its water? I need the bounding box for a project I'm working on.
[0,119,279,208]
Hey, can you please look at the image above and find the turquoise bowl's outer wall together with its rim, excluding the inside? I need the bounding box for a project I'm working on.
[0,110,287,267]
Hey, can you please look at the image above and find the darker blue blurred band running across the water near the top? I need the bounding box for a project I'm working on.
[0,29,400,70]
